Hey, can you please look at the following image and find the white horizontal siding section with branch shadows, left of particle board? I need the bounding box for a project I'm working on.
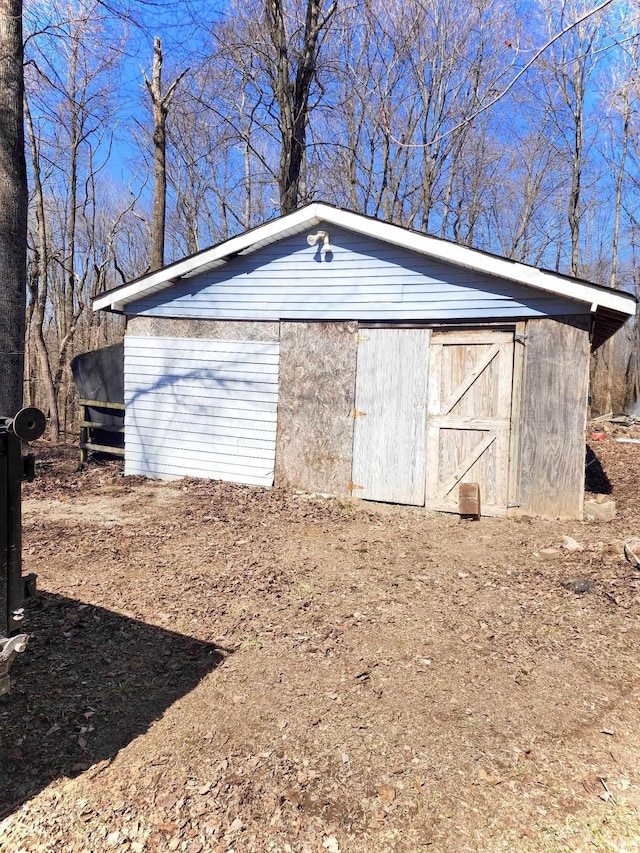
[124,335,279,486]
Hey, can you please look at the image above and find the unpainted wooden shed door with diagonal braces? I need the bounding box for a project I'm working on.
[425,330,514,515]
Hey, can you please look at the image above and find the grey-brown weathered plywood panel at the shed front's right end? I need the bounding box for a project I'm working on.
[514,316,590,518]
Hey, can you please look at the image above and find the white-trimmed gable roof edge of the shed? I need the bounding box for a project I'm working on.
[93,202,636,346]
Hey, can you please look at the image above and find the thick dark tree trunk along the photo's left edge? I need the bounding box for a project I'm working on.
[0,0,27,416]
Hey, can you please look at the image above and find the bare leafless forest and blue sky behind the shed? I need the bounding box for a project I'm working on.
[24,0,640,438]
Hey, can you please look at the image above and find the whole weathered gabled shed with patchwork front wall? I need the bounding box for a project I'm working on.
[94,203,636,518]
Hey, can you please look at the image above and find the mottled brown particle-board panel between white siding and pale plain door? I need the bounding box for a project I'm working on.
[275,322,358,495]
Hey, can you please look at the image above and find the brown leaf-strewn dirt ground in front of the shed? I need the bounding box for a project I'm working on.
[0,434,640,853]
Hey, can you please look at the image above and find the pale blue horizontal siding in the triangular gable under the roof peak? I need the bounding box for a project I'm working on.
[127,225,575,322]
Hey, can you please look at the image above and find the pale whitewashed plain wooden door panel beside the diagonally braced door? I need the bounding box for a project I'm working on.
[352,329,431,506]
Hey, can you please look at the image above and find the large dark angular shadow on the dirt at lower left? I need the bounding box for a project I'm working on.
[0,593,224,819]
